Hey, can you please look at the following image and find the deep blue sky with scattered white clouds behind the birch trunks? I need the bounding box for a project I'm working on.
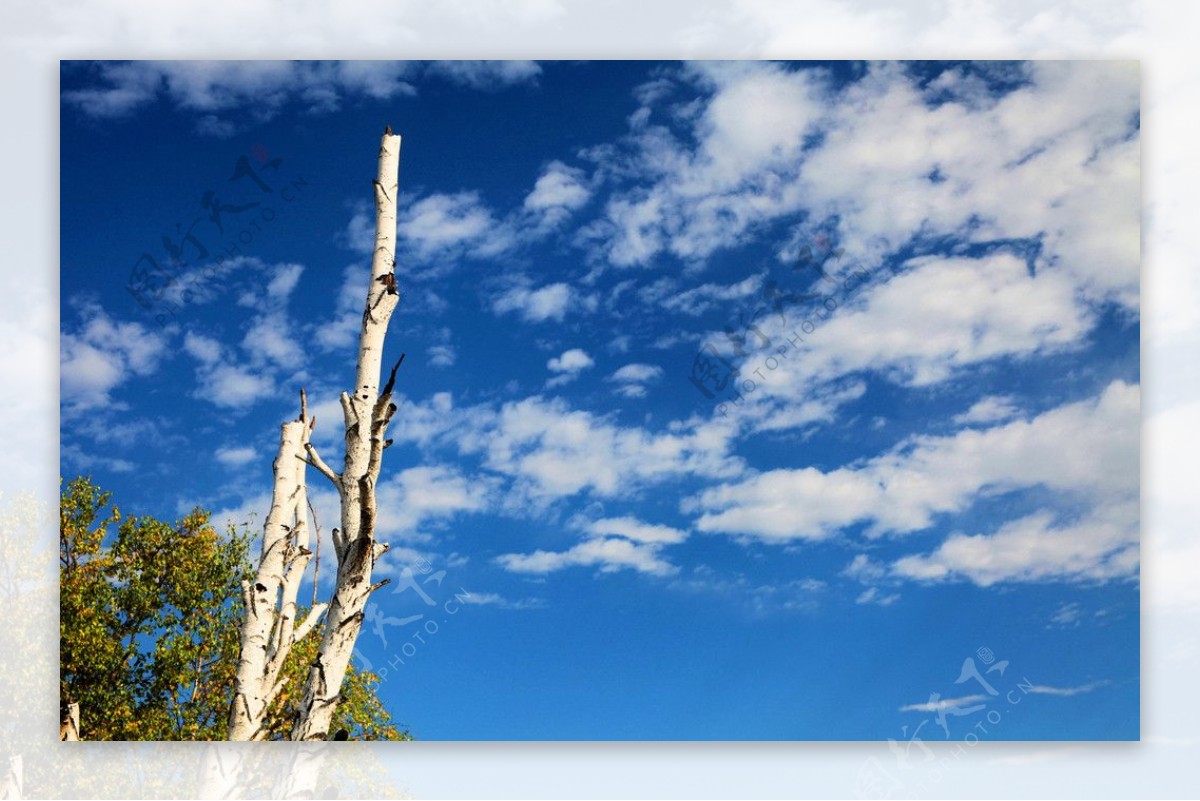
[61,62,1140,741]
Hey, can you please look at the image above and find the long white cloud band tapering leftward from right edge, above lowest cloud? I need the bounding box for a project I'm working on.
[685,381,1140,546]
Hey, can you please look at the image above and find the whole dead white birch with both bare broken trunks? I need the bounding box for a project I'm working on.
[229,126,404,740]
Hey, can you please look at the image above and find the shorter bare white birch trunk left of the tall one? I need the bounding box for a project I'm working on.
[229,390,325,740]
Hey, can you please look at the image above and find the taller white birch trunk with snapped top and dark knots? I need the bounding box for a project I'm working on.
[292,126,404,740]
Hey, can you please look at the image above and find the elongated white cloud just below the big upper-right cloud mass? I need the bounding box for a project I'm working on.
[748,252,1093,419]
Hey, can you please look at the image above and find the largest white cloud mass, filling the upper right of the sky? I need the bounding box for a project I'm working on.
[588,62,1140,419]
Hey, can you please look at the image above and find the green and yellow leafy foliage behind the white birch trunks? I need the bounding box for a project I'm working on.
[59,477,410,740]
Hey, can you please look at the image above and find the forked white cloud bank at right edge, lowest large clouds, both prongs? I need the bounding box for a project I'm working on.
[684,381,1140,585]
